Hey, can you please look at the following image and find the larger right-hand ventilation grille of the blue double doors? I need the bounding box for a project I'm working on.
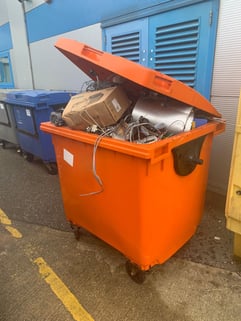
[154,19,199,87]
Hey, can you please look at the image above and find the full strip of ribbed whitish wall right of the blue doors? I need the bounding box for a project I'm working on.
[209,0,241,194]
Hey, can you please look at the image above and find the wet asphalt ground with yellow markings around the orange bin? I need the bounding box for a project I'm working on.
[0,146,241,321]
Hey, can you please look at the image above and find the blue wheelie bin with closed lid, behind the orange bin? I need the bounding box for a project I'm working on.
[6,90,74,174]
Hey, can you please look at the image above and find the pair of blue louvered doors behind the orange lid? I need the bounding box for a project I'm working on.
[105,0,219,99]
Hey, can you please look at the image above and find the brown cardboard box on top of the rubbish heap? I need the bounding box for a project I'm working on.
[62,86,131,130]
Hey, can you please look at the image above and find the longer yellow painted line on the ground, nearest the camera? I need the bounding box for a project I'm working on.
[34,257,94,321]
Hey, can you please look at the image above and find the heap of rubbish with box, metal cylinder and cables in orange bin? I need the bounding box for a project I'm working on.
[58,87,198,144]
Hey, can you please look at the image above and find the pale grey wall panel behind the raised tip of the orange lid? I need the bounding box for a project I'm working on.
[30,24,102,91]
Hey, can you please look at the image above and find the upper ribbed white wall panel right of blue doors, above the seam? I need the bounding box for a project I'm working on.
[212,0,241,96]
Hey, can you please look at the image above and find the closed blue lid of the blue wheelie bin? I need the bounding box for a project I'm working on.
[5,90,76,108]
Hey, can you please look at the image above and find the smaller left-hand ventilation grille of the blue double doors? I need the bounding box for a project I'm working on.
[111,32,140,63]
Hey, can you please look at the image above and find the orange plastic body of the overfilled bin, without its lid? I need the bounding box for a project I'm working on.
[41,122,224,270]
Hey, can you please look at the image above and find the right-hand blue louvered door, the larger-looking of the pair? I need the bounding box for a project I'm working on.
[149,1,217,98]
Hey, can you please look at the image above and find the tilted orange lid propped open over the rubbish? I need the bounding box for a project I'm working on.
[55,38,221,117]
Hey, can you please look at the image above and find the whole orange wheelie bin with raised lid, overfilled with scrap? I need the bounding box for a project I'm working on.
[41,38,225,283]
